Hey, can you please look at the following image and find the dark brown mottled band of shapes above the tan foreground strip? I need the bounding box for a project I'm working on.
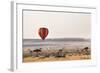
[23,47,91,58]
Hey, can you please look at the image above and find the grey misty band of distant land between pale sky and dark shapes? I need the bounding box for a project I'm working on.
[23,38,91,49]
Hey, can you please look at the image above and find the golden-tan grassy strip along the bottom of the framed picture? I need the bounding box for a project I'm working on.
[23,55,91,63]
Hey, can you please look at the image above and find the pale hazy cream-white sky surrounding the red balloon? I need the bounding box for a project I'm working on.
[23,11,91,39]
